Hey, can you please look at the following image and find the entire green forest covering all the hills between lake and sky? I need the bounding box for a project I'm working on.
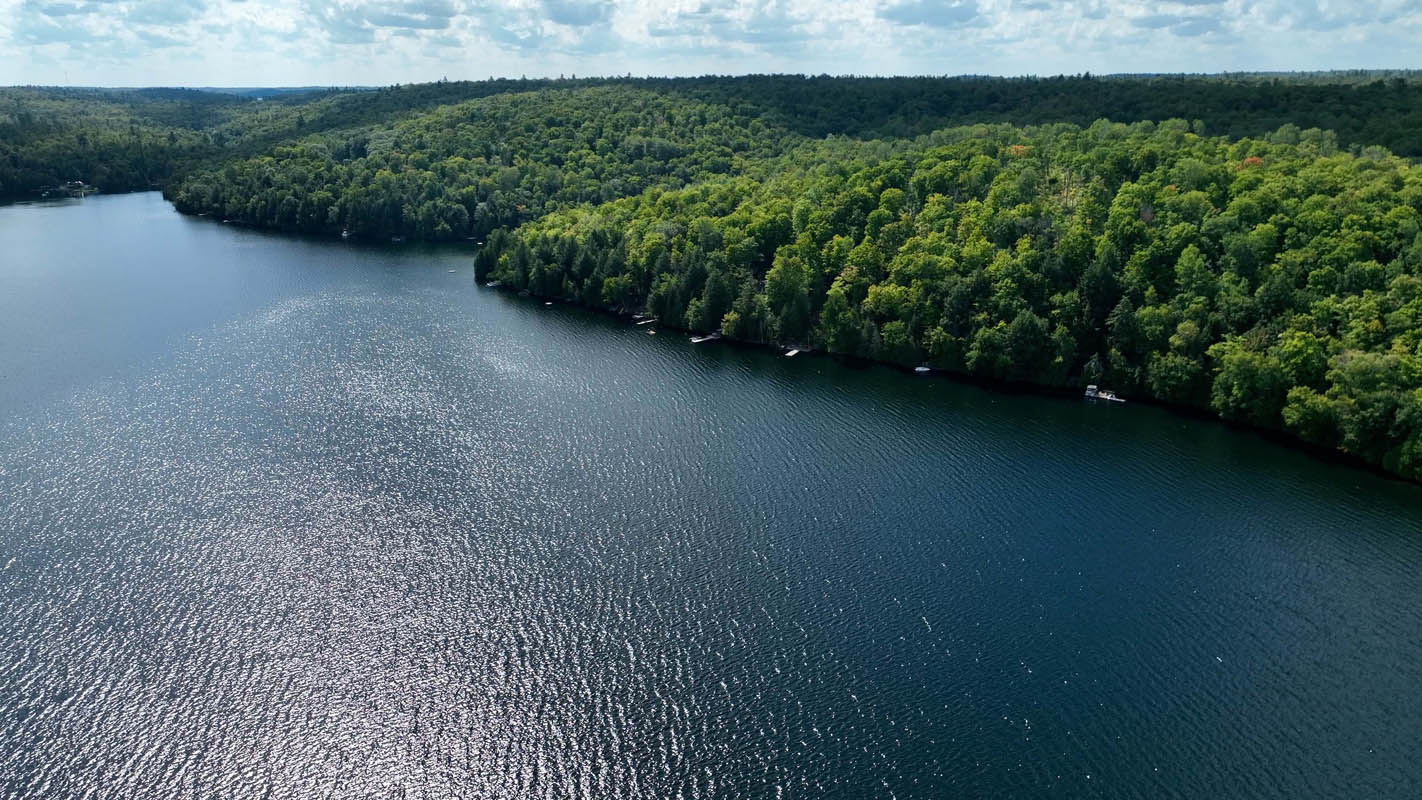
[8,74,1422,479]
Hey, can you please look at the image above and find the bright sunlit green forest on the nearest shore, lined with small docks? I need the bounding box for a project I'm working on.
[479,122,1422,479]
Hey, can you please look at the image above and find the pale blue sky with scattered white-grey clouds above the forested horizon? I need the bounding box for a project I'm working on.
[0,0,1422,85]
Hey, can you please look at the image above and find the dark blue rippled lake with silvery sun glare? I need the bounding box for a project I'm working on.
[0,195,1422,799]
